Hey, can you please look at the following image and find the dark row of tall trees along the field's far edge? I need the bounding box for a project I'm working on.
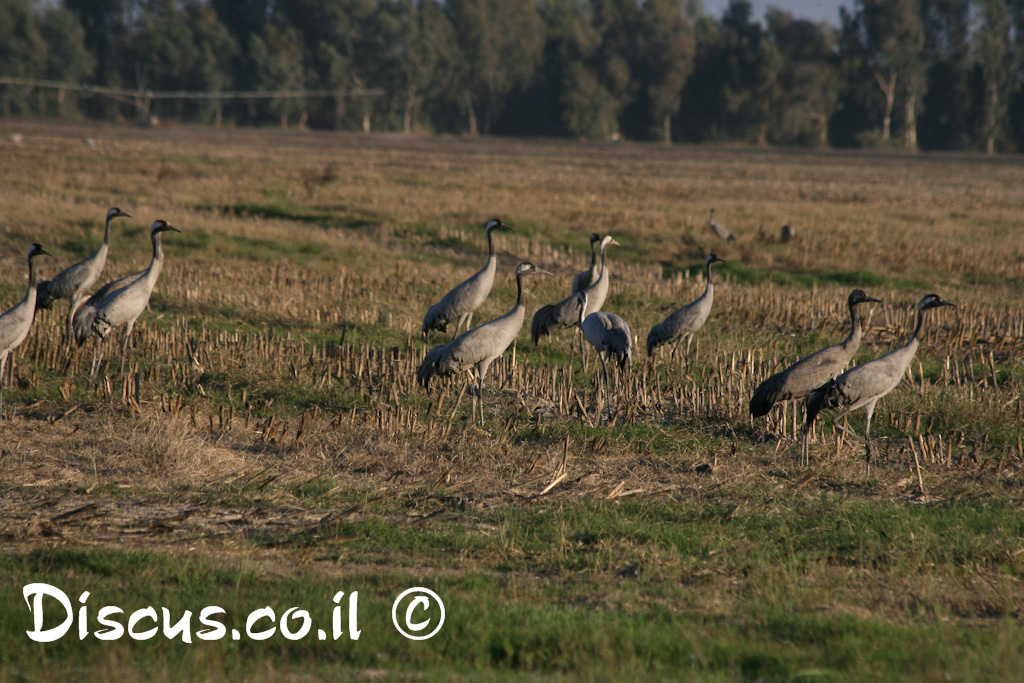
[0,0,1024,153]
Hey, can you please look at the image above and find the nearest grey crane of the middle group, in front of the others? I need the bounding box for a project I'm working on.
[417,261,551,425]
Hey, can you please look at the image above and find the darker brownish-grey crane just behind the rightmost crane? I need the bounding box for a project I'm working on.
[750,290,882,464]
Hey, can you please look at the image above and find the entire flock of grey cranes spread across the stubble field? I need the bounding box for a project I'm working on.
[0,207,954,466]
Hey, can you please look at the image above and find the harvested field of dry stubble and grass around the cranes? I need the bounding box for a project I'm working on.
[0,121,1024,680]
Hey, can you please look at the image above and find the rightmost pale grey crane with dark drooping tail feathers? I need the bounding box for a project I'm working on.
[804,294,956,469]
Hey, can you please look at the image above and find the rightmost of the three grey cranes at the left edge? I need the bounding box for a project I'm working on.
[74,220,181,377]
